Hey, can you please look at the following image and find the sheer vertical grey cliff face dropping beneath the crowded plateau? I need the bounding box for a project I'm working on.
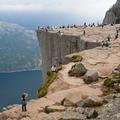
[37,30,100,80]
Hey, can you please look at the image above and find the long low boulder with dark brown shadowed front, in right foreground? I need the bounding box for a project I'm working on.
[76,96,104,107]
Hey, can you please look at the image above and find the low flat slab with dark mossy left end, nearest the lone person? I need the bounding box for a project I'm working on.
[45,105,65,113]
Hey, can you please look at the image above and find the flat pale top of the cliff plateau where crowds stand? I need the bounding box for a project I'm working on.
[38,24,120,42]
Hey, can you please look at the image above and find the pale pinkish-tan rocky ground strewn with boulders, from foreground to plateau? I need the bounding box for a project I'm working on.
[0,25,120,120]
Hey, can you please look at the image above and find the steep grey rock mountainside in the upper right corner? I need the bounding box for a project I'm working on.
[103,0,120,24]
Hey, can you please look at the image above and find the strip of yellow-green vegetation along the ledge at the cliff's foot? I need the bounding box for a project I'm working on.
[38,64,62,98]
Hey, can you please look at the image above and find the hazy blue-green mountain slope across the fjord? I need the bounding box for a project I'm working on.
[0,22,40,72]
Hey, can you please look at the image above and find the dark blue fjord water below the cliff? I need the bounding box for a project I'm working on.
[0,70,42,111]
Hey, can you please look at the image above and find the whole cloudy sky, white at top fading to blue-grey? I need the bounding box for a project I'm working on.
[0,0,116,30]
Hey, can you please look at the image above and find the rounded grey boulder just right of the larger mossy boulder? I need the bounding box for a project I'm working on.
[83,70,99,84]
